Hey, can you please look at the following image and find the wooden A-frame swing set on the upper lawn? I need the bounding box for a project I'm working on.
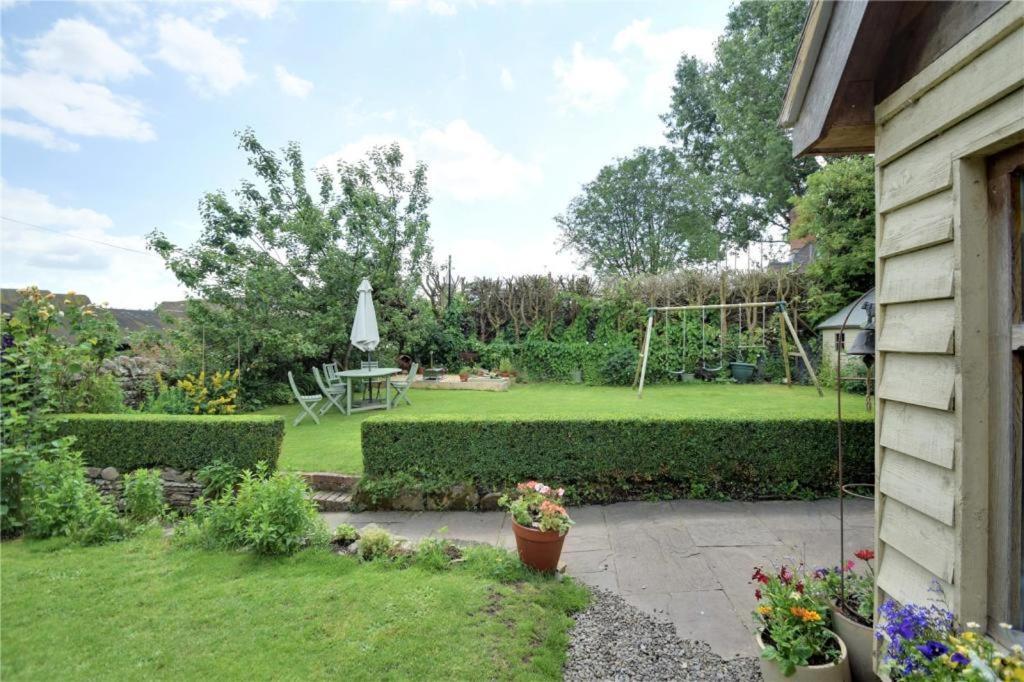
[637,301,824,397]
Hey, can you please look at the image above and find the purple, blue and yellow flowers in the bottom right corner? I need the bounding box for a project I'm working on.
[874,599,1024,681]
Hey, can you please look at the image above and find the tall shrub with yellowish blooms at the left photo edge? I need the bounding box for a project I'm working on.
[0,287,122,537]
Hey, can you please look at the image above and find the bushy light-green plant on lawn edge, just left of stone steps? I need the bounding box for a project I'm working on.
[175,466,321,555]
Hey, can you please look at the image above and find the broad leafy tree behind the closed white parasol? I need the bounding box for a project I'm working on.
[148,130,430,398]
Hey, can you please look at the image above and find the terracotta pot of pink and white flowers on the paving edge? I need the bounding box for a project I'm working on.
[498,480,572,572]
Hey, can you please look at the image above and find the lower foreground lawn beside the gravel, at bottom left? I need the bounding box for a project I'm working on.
[0,530,587,681]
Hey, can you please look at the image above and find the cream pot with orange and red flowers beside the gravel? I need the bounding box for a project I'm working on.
[753,566,850,682]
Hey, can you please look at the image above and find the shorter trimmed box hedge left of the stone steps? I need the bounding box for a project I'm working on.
[57,415,285,471]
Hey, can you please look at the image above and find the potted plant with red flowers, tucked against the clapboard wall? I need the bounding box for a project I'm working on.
[810,548,877,682]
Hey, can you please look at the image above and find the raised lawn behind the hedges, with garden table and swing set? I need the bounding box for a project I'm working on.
[262,384,867,473]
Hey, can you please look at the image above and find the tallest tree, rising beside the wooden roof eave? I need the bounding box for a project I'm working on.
[663,0,818,246]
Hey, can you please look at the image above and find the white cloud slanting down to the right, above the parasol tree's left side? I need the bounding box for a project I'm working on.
[157,16,250,94]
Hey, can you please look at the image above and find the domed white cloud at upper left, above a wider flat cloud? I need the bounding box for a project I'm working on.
[25,19,148,81]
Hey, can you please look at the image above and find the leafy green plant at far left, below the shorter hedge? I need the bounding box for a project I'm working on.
[23,439,125,545]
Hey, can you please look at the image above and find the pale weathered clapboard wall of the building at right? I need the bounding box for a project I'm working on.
[876,2,1024,623]
